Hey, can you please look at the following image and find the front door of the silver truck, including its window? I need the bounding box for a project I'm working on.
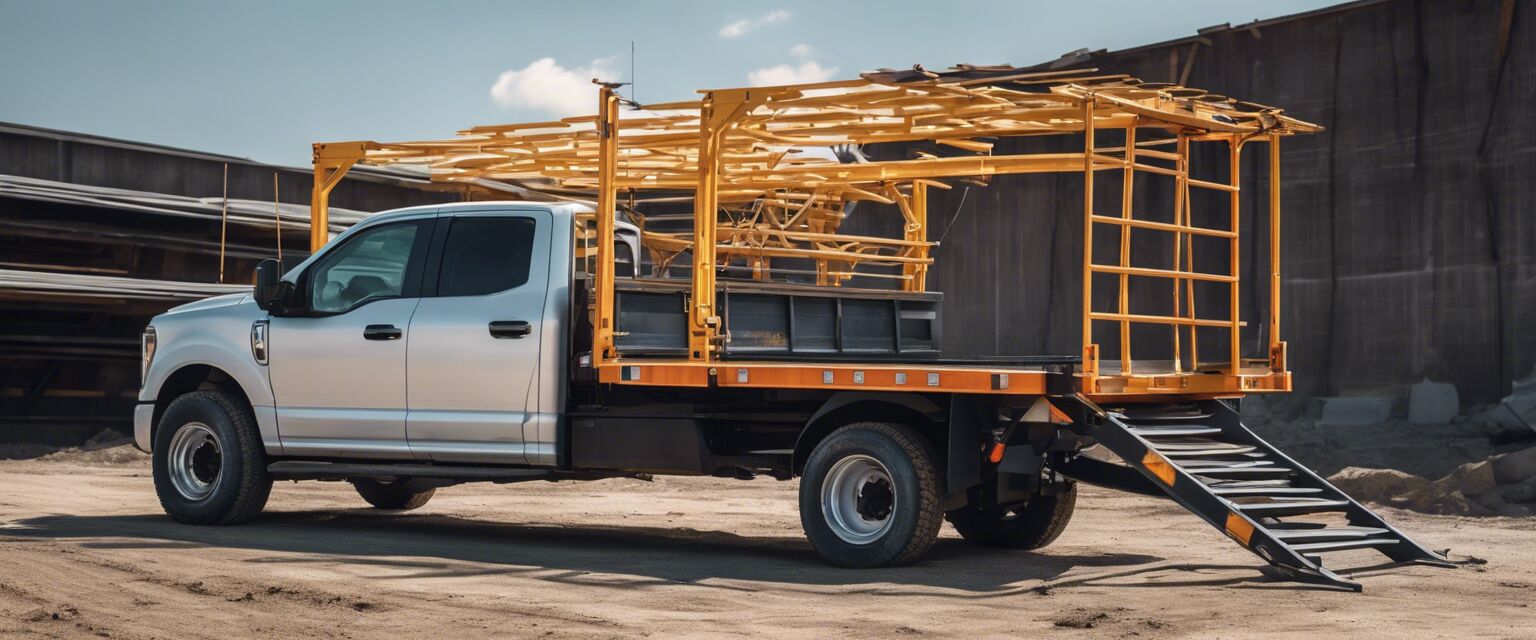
[267,218,432,457]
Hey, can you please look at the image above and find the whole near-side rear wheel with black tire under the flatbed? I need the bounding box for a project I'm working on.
[800,422,943,568]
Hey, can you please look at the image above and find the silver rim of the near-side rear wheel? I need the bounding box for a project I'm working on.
[822,454,897,545]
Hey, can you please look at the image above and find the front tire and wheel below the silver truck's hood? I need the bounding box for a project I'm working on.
[152,391,272,525]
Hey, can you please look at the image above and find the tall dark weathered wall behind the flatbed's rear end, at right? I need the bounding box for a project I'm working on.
[852,0,1536,402]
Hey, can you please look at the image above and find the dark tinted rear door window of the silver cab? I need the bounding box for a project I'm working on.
[438,216,535,296]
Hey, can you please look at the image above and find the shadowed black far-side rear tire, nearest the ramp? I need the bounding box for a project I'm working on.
[945,482,1077,549]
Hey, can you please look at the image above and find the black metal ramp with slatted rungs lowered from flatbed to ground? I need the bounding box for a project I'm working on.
[1078,396,1453,591]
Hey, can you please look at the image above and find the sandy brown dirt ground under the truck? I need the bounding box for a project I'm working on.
[0,450,1536,638]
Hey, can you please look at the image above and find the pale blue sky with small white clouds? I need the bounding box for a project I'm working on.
[0,0,1333,164]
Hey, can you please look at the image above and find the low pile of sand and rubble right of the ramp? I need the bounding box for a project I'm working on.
[1329,447,1536,516]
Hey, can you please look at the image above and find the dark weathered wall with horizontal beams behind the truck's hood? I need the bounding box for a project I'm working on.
[0,124,461,445]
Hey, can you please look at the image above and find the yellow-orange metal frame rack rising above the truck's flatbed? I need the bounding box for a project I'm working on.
[312,66,1319,398]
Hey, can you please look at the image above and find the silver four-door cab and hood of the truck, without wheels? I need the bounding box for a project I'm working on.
[135,203,634,465]
